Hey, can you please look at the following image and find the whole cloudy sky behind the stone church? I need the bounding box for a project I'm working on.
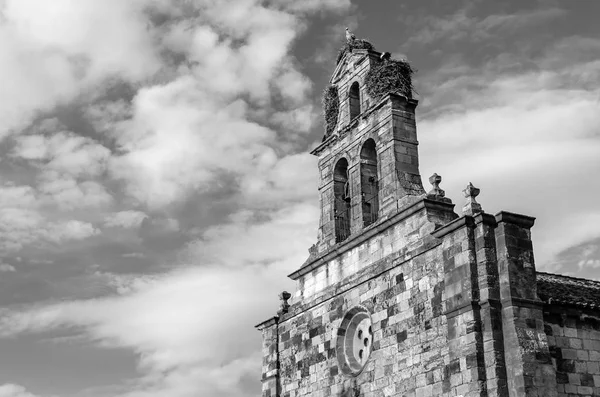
[0,0,600,397]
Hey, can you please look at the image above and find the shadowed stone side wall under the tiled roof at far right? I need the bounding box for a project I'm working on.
[544,304,600,397]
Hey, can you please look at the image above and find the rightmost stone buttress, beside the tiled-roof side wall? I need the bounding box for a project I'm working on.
[496,212,558,397]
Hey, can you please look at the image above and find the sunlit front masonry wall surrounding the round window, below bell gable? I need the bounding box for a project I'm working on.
[272,200,506,397]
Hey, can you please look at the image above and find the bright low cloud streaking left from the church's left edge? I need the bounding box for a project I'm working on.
[0,197,317,397]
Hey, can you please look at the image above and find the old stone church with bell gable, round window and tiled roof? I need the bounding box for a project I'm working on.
[256,32,600,397]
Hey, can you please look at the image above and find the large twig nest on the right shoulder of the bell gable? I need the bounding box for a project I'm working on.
[365,59,416,100]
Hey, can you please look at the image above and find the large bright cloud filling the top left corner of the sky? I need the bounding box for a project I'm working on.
[0,0,161,136]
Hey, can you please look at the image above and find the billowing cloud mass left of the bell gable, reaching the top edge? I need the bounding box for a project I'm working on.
[94,1,338,209]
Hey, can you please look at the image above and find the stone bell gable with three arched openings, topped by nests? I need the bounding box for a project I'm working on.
[311,39,425,252]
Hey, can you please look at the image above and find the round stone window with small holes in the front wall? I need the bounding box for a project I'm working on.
[336,307,373,376]
